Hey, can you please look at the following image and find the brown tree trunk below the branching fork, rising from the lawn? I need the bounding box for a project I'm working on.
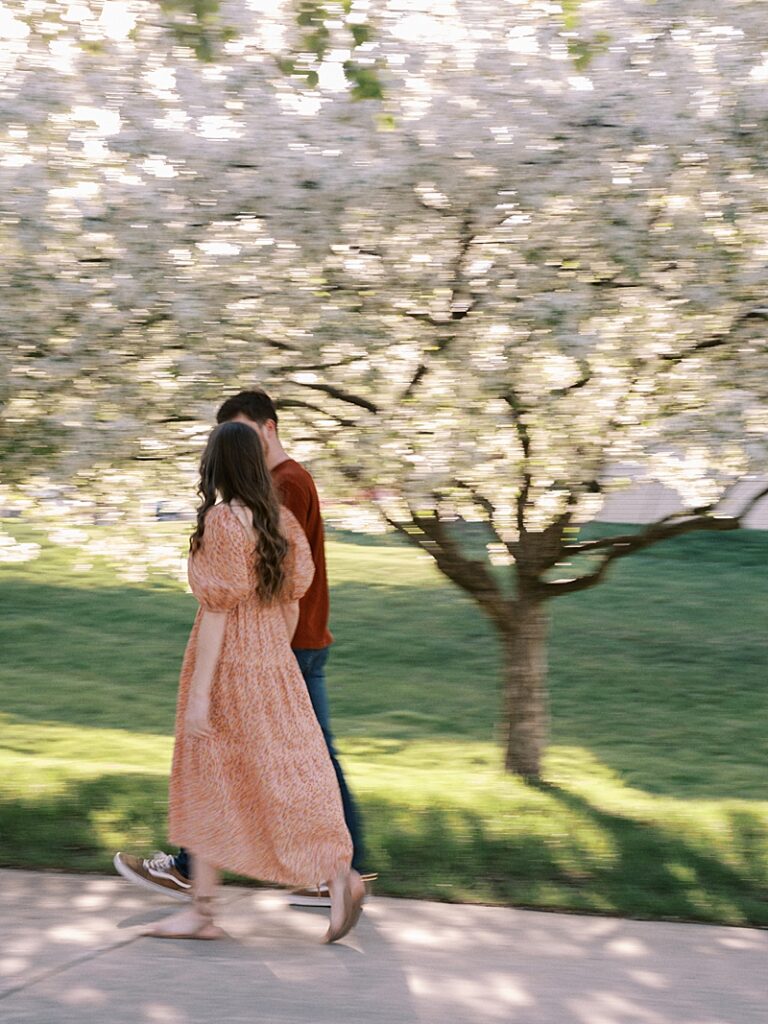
[502,597,549,778]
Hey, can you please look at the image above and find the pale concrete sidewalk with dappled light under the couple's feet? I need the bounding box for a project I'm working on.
[0,870,768,1024]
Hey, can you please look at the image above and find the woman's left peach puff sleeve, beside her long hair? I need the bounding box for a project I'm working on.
[186,505,256,611]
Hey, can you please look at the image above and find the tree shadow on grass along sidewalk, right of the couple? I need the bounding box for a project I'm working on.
[365,785,768,926]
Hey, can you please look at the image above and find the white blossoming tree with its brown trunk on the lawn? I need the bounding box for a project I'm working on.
[0,0,768,776]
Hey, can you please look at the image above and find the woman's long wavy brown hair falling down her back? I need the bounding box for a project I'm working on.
[189,422,288,602]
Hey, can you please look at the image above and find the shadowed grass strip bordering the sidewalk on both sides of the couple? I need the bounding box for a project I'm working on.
[0,773,768,926]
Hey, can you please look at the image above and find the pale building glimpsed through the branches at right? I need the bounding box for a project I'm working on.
[597,473,768,529]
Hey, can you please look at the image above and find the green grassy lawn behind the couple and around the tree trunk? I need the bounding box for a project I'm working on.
[0,522,768,925]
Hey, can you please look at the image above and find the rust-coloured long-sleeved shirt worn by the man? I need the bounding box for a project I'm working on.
[272,459,333,650]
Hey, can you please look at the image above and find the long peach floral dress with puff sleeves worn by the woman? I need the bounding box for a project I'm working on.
[169,504,352,886]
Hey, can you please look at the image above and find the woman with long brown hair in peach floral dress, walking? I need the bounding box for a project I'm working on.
[145,422,365,942]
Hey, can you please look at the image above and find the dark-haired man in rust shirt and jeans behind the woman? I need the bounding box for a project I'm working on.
[114,390,374,906]
